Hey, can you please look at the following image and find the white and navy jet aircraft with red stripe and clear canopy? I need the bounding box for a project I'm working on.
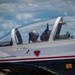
[0,17,75,75]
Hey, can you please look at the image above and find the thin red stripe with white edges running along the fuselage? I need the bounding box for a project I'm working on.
[0,55,75,62]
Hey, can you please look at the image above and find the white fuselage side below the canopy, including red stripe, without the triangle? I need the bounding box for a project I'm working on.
[0,39,75,62]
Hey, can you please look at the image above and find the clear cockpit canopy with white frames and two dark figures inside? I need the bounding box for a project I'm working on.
[0,17,75,47]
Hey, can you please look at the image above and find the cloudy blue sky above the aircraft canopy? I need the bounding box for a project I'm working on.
[0,0,75,36]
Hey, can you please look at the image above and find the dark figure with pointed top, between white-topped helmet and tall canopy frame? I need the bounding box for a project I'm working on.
[40,24,51,41]
